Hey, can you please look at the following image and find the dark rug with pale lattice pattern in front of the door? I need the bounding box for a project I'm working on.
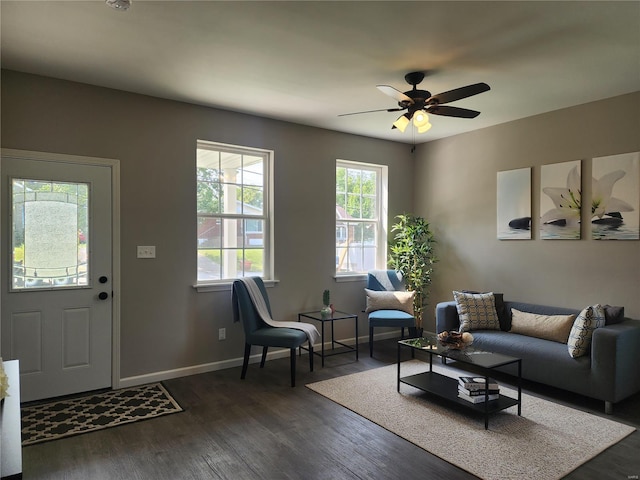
[21,383,182,446]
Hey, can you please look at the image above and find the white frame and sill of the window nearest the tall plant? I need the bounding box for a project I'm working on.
[334,159,389,281]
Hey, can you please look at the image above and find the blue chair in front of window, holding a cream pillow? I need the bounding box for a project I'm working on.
[367,270,416,357]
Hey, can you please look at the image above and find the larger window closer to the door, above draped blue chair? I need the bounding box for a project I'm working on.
[196,141,273,284]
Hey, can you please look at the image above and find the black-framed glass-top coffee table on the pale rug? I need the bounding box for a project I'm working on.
[398,332,522,430]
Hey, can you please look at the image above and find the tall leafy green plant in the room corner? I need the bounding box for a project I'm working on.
[389,214,438,336]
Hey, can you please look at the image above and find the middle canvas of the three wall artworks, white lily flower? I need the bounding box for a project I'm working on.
[540,160,582,240]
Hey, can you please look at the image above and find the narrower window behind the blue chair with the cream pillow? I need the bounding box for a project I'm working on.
[336,160,387,275]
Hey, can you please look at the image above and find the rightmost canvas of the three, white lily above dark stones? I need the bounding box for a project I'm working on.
[591,152,640,240]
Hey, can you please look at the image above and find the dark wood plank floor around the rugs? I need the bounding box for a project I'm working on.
[23,340,640,480]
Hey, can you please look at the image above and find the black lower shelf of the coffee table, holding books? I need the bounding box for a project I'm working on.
[398,372,518,420]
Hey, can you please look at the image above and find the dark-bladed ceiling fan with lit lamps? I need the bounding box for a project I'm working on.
[339,72,491,133]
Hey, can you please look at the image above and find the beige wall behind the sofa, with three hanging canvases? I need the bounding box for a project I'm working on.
[414,92,640,327]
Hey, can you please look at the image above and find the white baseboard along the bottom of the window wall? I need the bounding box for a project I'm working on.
[114,329,398,388]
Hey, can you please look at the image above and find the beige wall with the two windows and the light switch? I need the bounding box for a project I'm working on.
[2,71,413,378]
